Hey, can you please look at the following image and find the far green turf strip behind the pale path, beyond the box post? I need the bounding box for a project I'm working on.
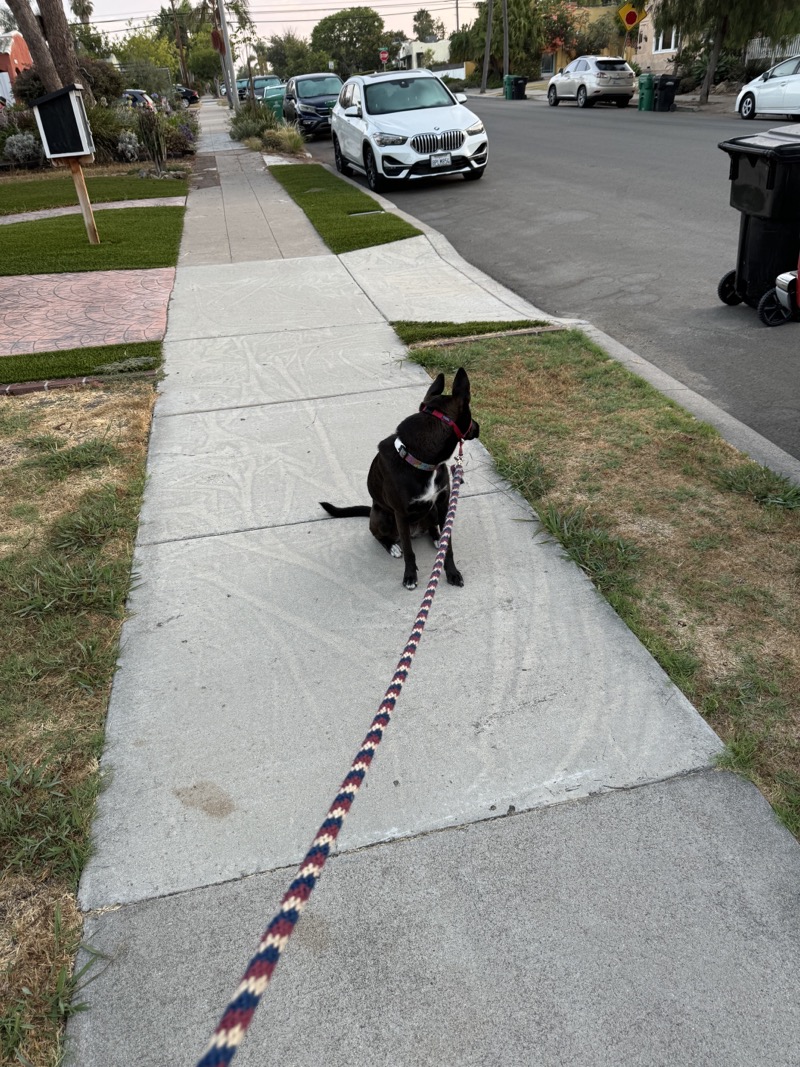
[0,175,188,214]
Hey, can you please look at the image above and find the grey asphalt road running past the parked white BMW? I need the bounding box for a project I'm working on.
[309,97,800,459]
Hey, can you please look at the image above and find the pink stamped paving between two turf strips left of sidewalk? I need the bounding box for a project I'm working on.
[0,267,175,356]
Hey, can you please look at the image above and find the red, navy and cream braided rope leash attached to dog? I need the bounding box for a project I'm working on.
[197,458,464,1067]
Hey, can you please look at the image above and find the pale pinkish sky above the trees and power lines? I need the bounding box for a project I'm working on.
[75,0,476,48]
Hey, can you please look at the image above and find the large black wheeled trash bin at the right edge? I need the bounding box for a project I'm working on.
[717,125,800,307]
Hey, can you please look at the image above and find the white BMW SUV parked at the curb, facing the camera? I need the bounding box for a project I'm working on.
[331,70,489,192]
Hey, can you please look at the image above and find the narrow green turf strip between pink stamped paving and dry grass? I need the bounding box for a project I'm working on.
[0,340,161,385]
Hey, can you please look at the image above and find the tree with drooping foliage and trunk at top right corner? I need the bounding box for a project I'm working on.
[655,0,800,103]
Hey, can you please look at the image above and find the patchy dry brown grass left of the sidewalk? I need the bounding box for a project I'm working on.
[0,382,155,1067]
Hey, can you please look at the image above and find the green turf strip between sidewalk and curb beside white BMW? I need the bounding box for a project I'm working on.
[270,163,420,255]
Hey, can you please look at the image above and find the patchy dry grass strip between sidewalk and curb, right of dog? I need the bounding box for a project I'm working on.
[395,322,800,837]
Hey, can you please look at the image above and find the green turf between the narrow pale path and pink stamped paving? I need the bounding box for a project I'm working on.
[0,207,185,276]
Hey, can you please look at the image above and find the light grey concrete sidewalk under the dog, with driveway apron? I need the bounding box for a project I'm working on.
[66,100,800,1067]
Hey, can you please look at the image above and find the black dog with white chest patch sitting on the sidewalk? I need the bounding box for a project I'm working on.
[320,367,480,589]
